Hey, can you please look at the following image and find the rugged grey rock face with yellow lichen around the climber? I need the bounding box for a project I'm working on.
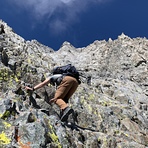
[0,21,148,148]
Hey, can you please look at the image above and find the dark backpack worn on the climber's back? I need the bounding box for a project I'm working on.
[52,64,81,84]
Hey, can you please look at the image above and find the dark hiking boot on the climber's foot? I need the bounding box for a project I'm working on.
[60,107,73,122]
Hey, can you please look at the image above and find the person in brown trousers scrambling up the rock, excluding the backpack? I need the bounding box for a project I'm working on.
[26,66,80,122]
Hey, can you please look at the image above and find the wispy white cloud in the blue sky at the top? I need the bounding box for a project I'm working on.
[10,0,110,33]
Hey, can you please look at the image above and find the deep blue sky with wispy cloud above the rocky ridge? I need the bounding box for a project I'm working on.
[0,0,148,50]
